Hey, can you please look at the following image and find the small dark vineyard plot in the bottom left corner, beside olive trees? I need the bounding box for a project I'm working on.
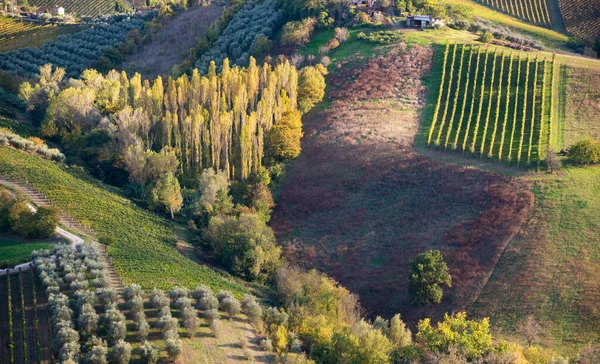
[0,270,52,363]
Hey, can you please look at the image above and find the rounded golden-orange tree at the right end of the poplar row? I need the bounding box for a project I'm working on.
[265,110,303,161]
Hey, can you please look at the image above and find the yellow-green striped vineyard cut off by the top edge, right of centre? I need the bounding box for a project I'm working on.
[477,0,552,28]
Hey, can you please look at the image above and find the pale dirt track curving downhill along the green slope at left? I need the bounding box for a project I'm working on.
[0,177,125,295]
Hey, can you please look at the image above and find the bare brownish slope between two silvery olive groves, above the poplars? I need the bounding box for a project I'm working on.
[123,5,224,79]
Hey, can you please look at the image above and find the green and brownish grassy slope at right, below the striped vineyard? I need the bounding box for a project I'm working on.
[471,167,600,355]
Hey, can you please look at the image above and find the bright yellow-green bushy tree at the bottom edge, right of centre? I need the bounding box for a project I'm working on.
[417,312,492,360]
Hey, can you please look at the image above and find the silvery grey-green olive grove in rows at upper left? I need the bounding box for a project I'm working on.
[0,16,144,78]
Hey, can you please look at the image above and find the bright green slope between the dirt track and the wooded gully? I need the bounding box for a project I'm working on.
[0,147,245,295]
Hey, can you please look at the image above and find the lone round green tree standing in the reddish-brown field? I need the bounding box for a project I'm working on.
[409,250,452,304]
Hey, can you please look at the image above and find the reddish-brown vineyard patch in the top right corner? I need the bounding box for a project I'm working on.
[558,0,600,39]
